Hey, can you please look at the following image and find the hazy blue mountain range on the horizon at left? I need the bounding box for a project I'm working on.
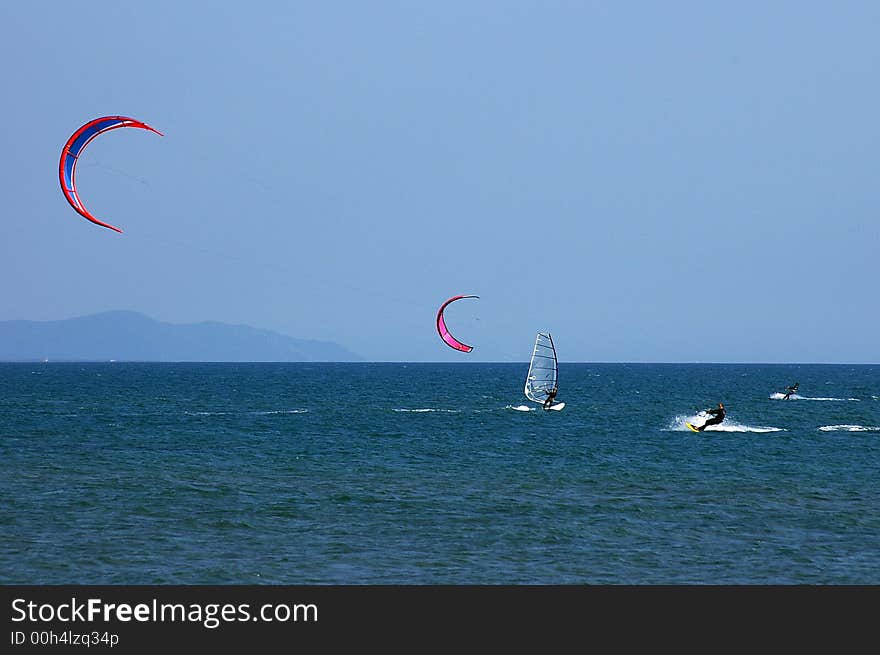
[0,311,363,362]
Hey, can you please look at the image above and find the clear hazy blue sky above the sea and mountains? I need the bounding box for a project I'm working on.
[0,1,880,363]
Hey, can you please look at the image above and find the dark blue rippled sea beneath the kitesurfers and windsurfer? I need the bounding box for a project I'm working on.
[0,362,880,585]
